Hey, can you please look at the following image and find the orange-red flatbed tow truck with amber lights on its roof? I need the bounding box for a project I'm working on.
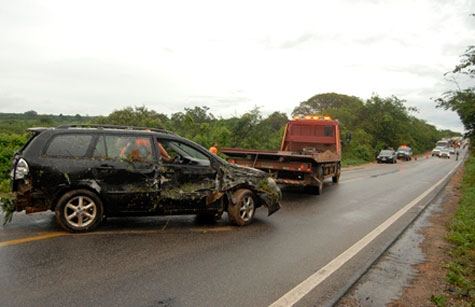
[221,115,351,195]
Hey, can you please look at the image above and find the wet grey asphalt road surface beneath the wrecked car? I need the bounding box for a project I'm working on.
[0,153,466,306]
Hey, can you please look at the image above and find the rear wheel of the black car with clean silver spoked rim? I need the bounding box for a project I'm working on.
[55,189,104,232]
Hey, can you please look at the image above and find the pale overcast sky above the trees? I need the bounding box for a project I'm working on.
[0,0,475,131]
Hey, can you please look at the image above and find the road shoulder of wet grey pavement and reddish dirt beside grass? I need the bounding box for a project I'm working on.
[337,162,463,307]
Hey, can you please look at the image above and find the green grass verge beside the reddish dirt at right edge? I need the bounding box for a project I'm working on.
[446,156,475,306]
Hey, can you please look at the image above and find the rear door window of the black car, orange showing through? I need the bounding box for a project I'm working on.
[93,135,154,162]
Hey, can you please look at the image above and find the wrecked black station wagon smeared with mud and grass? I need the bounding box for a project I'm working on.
[11,125,281,232]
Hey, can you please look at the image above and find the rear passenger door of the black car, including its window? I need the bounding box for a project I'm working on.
[93,134,159,212]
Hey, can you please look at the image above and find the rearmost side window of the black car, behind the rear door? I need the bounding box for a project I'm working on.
[45,134,92,158]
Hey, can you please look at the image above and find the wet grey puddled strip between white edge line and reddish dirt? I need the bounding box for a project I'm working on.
[337,192,445,306]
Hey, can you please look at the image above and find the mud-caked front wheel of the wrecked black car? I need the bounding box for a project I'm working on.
[228,189,256,226]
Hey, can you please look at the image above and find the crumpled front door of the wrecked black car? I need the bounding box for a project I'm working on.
[157,139,220,213]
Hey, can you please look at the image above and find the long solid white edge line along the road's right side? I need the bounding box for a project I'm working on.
[269,159,463,307]
